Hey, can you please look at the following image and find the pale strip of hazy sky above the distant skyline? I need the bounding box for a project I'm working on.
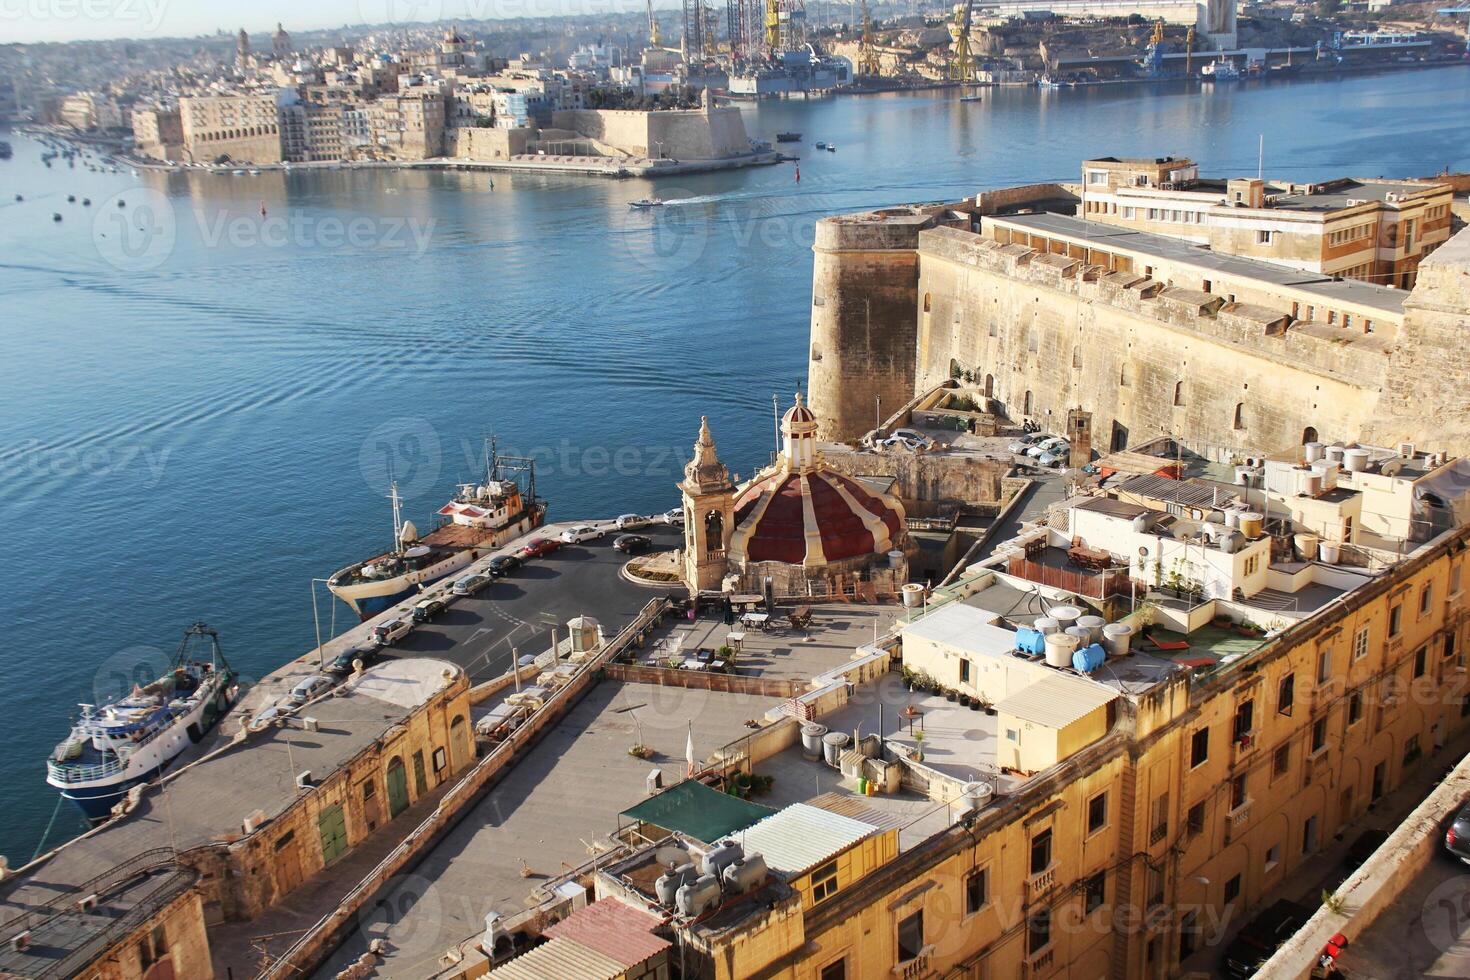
[0,0,655,47]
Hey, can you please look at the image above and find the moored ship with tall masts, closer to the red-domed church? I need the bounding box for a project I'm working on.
[326,441,547,620]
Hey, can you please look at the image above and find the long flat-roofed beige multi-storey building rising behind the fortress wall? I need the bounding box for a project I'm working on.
[1079,157,1452,289]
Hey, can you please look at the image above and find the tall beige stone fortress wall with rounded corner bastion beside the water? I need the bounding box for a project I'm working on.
[810,199,1470,454]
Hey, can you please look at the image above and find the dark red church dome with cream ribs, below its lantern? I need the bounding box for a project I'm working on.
[731,467,904,566]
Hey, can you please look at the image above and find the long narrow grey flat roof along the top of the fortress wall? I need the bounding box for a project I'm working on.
[986,215,1408,313]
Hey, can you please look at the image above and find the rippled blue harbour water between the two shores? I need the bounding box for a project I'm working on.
[0,69,1470,862]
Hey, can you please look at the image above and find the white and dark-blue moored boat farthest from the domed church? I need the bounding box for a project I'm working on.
[46,623,240,821]
